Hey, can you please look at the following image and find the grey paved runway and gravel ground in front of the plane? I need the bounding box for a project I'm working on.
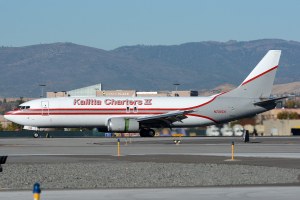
[0,137,300,200]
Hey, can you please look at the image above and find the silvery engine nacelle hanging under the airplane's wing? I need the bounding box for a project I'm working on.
[107,117,140,133]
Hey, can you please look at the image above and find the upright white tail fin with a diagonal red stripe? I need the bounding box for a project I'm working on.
[224,50,281,98]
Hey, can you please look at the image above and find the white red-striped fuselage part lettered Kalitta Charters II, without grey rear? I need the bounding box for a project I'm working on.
[5,96,218,127]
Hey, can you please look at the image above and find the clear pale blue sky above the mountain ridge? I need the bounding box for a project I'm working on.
[0,0,300,50]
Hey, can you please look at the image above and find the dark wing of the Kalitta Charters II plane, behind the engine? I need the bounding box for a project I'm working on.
[137,110,194,128]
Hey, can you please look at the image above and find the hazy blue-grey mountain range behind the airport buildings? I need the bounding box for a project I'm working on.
[0,39,300,97]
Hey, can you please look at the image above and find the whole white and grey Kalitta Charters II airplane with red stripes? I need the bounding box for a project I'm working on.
[4,50,284,137]
